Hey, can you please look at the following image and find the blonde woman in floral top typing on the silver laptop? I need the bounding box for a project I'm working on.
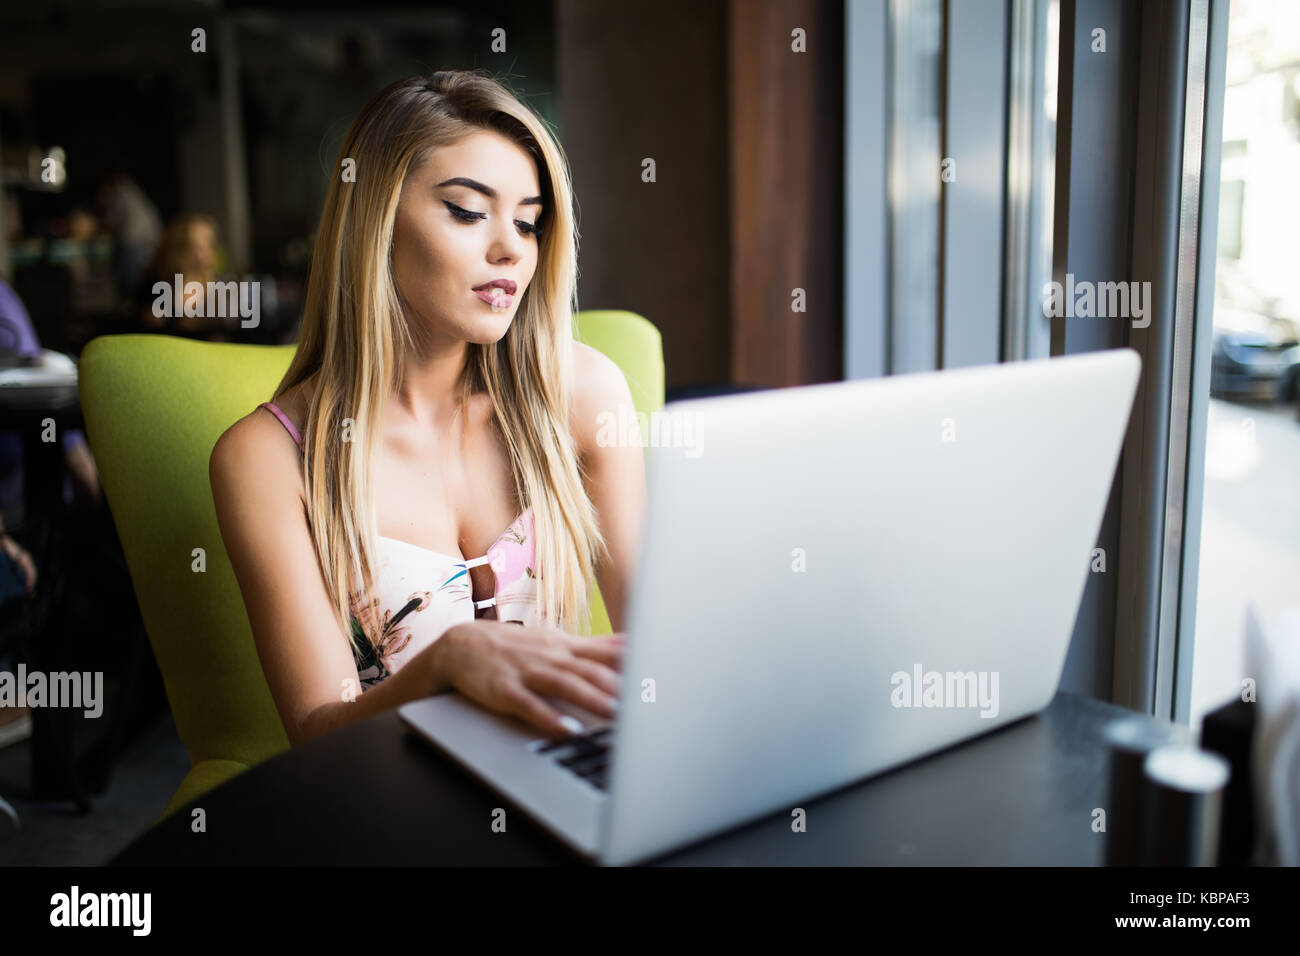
[211,72,645,744]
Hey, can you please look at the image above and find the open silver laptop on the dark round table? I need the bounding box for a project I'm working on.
[400,349,1140,865]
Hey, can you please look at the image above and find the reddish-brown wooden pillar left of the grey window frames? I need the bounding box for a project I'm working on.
[728,0,844,388]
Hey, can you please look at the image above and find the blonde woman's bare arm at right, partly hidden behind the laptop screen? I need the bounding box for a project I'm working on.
[571,342,646,632]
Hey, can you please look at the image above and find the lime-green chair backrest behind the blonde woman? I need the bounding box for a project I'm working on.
[79,311,664,765]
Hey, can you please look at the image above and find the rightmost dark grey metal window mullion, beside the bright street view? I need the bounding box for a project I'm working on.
[1113,0,1204,718]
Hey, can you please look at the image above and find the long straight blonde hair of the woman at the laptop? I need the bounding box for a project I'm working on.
[273,70,608,658]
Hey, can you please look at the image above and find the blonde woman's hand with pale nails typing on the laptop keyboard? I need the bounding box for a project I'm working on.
[429,619,623,737]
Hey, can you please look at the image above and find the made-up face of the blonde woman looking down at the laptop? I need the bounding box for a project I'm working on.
[393,131,542,345]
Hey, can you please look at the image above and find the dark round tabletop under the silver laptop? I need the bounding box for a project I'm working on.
[111,692,1192,866]
